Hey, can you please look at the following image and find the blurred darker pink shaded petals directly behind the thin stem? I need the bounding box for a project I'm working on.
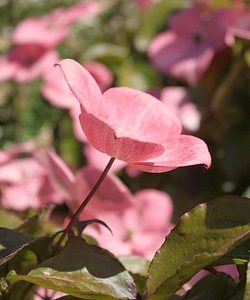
[36,149,132,218]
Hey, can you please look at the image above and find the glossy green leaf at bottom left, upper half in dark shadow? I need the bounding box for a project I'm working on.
[7,236,137,300]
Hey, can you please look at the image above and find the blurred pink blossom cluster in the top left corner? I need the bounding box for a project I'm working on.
[0,1,101,82]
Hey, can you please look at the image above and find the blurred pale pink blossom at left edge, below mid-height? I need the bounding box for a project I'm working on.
[0,157,61,210]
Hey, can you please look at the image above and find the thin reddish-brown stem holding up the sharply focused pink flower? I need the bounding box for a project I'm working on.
[52,157,115,253]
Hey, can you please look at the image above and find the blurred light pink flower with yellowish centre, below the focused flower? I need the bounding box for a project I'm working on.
[85,189,173,259]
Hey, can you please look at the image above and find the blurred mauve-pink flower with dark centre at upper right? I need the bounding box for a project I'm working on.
[148,7,230,83]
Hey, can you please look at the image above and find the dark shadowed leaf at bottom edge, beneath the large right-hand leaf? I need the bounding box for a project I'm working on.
[184,273,236,300]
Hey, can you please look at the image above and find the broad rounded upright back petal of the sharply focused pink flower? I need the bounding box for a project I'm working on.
[103,87,182,144]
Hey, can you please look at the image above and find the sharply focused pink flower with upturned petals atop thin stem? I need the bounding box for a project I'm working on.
[58,59,211,172]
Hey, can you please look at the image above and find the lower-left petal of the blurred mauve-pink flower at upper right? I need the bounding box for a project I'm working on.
[148,31,214,83]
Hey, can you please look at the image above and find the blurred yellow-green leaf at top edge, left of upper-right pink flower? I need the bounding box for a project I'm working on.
[135,0,184,51]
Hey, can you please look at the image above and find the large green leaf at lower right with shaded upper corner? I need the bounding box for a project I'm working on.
[147,196,250,300]
